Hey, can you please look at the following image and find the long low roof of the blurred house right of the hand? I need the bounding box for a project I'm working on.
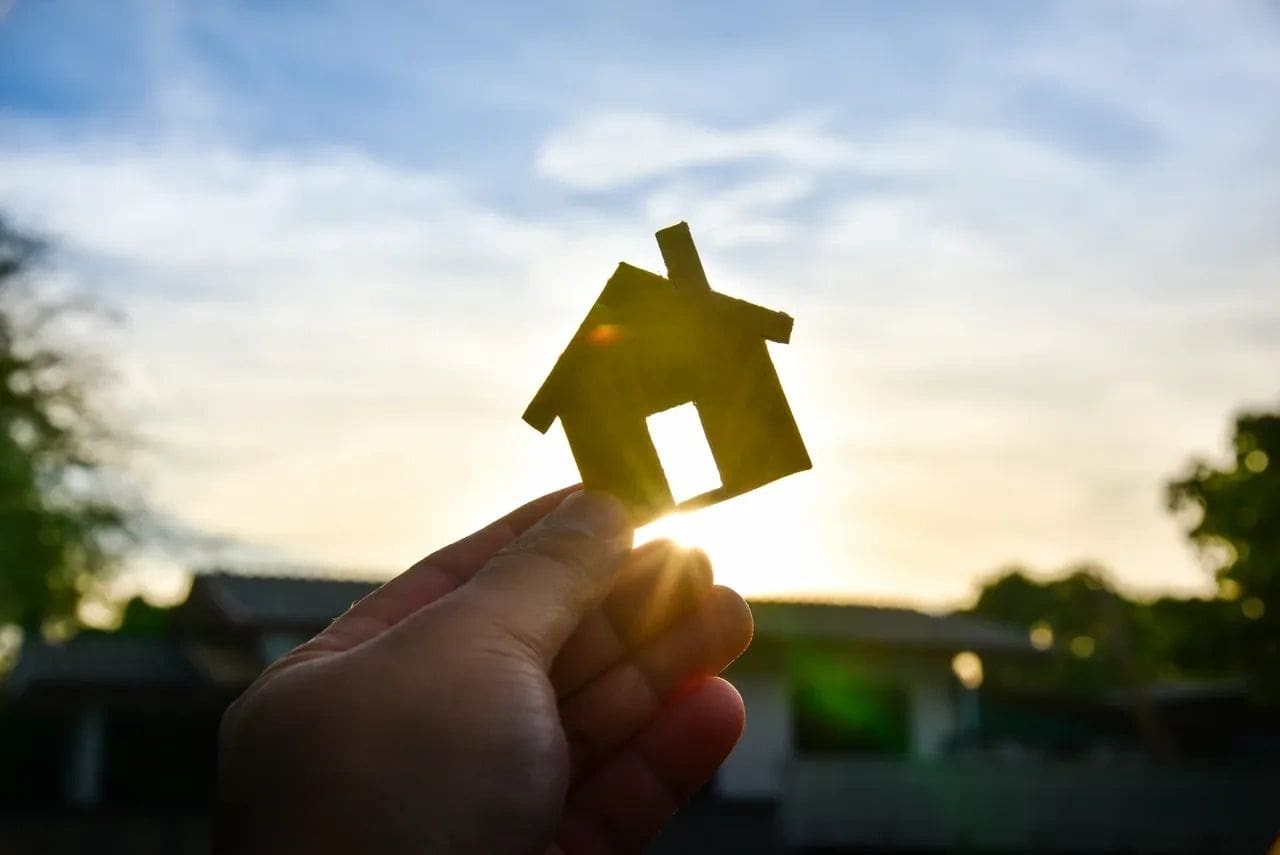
[751,600,1034,654]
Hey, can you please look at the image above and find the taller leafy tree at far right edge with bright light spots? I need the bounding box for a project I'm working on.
[1169,412,1280,700]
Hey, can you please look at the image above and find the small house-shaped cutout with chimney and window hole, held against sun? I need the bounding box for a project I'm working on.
[525,223,813,525]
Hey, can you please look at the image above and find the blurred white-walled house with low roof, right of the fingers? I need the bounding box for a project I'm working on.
[717,600,1036,800]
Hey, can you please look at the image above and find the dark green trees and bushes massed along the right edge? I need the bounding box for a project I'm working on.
[972,412,1280,701]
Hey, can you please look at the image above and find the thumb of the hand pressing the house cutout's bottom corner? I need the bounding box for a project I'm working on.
[456,491,632,667]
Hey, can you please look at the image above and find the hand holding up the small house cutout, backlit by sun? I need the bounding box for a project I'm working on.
[215,490,751,855]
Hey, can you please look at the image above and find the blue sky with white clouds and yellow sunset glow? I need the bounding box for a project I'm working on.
[0,0,1280,608]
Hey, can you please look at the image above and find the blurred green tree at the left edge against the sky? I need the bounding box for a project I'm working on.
[0,216,125,632]
